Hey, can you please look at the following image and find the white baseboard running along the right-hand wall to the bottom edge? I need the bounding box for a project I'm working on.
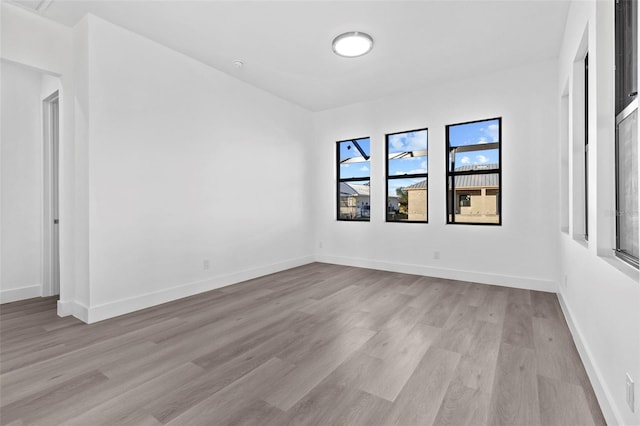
[558,293,624,425]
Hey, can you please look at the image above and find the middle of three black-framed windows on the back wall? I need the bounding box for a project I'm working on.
[386,129,429,223]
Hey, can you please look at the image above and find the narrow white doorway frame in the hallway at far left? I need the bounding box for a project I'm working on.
[42,90,60,296]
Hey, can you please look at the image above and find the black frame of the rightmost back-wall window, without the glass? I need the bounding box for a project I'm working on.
[445,116,502,226]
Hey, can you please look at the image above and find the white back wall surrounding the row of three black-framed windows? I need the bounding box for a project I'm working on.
[314,62,559,291]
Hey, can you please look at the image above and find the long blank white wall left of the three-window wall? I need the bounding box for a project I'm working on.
[76,16,312,322]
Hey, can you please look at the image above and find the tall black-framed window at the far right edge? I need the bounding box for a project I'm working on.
[615,0,639,268]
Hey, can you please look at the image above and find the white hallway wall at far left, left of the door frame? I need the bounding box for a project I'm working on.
[0,61,42,303]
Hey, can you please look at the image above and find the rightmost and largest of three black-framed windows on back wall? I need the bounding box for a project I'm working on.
[446,118,502,225]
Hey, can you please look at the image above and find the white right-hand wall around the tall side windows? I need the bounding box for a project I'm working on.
[556,1,640,425]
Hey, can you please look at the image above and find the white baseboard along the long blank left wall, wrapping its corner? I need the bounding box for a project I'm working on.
[80,256,313,324]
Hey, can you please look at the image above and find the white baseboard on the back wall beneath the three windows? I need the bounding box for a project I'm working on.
[315,255,557,293]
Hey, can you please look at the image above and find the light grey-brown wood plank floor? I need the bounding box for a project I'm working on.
[0,263,605,425]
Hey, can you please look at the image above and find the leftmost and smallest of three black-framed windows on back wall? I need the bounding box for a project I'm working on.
[336,138,371,221]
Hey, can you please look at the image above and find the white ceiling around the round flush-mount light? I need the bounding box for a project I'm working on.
[12,0,569,111]
